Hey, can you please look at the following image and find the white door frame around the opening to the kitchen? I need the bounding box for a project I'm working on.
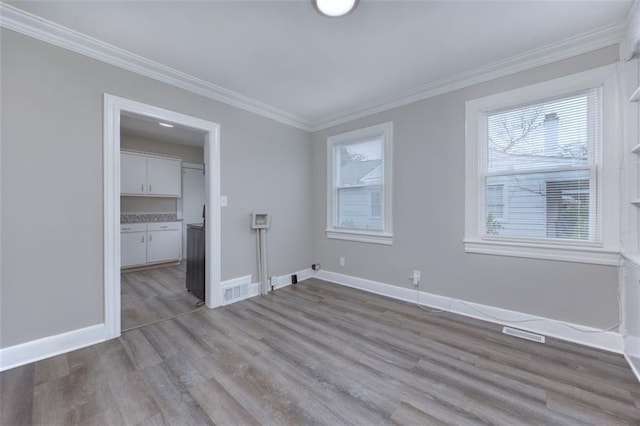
[103,93,222,339]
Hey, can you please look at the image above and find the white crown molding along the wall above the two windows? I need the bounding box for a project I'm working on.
[311,21,626,132]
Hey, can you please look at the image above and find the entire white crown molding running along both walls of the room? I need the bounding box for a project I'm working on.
[0,2,627,132]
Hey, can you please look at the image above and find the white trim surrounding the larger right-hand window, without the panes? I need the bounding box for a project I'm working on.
[463,64,621,265]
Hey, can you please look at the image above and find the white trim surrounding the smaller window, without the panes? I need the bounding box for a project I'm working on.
[326,121,393,245]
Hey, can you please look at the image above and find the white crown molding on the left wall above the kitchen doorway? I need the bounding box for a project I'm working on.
[0,2,311,131]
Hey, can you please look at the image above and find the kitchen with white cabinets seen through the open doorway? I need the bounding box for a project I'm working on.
[120,114,205,331]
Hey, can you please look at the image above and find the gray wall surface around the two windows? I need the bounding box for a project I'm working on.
[313,47,619,327]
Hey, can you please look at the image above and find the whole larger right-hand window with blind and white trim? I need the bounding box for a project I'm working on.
[465,67,619,264]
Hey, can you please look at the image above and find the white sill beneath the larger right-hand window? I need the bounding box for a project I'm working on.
[464,239,621,266]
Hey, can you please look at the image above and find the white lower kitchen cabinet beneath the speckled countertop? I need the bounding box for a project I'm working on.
[120,222,182,268]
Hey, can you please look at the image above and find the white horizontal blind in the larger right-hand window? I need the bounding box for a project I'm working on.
[478,88,602,243]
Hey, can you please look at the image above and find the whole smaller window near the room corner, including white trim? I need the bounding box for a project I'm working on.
[327,123,393,244]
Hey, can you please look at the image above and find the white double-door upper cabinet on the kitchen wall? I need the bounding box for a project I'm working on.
[120,151,182,197]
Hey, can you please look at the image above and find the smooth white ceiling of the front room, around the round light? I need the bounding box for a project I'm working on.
[6,0,632,125]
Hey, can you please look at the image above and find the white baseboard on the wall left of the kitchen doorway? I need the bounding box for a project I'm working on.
[0,324,106,371]
